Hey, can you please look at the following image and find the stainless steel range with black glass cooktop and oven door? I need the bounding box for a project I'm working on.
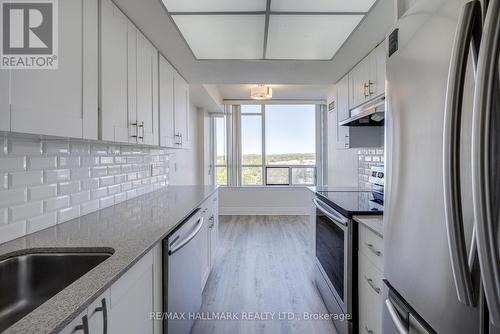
[313,187,382,334]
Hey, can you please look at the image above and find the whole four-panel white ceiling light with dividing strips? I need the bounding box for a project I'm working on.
[162,0,375,60]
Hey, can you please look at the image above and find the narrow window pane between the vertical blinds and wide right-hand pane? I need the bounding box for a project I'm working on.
[241,105,263,186]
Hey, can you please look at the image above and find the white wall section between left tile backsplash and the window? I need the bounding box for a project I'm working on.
[169,103,203,185]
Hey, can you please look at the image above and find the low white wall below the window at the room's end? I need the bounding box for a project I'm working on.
[219,187,313,215]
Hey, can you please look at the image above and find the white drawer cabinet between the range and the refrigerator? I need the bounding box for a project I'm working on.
[358,224,383,334]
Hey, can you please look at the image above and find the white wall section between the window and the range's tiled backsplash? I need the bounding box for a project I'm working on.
[327,88,358,187]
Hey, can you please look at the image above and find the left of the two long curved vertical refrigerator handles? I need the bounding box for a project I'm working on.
[443,1,481,306]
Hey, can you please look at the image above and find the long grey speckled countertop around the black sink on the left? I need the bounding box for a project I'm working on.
[0,186,217,334]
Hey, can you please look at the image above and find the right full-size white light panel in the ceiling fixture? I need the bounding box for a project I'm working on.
[266,15,363,60]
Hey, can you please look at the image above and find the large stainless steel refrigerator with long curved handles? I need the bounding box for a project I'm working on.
[383,0,500,334]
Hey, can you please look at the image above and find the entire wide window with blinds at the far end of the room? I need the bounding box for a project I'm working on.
[212,104,322,186]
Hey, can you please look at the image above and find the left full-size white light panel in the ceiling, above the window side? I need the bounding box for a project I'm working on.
[172,15,265,59]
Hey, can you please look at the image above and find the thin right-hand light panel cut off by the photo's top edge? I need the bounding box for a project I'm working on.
[271,0,376,12]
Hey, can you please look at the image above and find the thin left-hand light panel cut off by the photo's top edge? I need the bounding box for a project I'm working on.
[162,0,266,12]
